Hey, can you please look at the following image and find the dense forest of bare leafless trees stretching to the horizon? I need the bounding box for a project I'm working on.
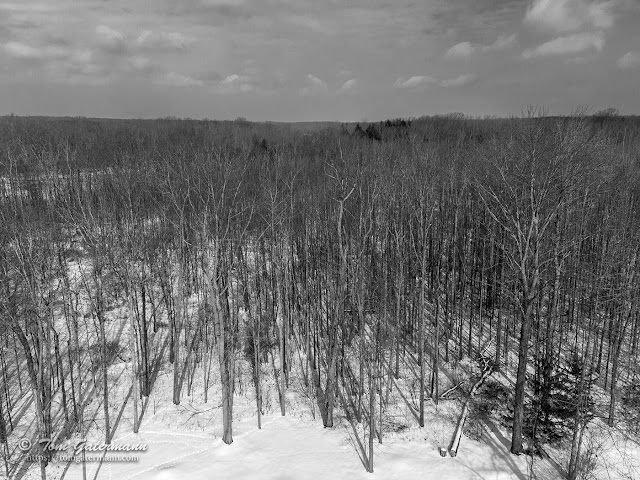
[0,112,640,480]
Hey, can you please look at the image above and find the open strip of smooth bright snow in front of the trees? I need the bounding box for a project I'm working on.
[52,416,525,480]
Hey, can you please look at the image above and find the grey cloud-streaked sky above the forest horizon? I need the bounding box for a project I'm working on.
[0,0,640,121]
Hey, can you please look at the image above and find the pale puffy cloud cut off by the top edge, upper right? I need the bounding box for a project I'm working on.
[524,0,618,33]
